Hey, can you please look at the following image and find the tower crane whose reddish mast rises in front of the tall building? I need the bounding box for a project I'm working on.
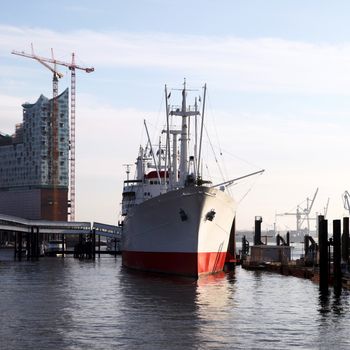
[12,44,63,220]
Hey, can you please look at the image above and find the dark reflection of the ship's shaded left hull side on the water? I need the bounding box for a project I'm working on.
[118,269,199,349]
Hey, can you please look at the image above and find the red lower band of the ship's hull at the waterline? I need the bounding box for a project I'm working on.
[122,251,226,277]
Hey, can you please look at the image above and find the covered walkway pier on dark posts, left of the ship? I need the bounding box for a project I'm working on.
[0,215,121,261]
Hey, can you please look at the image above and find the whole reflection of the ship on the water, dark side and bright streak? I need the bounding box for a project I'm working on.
[116,270,239,349]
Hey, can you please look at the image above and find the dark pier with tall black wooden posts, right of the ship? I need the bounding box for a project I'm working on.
[241,216,350,292]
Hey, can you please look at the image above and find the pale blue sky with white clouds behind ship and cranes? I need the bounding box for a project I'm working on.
[0,0,350,230]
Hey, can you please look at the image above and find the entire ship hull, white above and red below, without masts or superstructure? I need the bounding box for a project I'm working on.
[122,186,236,277]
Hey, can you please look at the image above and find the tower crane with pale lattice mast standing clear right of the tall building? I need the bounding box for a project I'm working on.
[12,45,95,221]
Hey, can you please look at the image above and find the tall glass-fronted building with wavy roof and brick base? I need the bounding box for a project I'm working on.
[0,89,69,221]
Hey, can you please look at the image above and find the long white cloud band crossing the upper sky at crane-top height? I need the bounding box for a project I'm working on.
[0,26,350,95]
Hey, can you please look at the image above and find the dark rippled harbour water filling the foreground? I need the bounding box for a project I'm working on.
[0,250,350,350]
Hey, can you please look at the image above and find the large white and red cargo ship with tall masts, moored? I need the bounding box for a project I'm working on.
[121,82,258,278]
